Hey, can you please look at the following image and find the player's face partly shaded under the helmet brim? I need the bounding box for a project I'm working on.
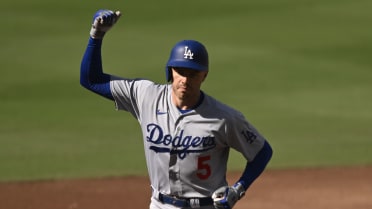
[172,68,208,100]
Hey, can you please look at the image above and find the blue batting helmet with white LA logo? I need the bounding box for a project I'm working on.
[165,40,208,81]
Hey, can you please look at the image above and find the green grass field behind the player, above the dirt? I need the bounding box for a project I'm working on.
[0,0,372,181]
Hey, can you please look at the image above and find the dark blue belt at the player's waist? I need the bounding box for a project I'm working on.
[158,193,213,208]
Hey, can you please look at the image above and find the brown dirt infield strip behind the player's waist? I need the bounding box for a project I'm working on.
[0,167,372,209]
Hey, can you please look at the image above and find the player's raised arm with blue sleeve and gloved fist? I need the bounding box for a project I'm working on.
[80,10,120,100]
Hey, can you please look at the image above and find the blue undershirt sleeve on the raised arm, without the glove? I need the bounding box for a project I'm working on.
[80,37,114,100]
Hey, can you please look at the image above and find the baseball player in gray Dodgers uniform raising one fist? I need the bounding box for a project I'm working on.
[80,10,272,209]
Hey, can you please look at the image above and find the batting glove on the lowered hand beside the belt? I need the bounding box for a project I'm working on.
[212,182,245,209]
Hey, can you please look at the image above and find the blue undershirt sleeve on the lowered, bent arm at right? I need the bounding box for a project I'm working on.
[238,141,273,190]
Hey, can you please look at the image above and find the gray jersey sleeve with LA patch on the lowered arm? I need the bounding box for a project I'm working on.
[227,112,266,161]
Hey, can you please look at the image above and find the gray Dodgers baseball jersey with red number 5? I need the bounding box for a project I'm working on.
[110,79,265,197]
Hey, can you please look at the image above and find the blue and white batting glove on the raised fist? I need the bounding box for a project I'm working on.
[90,9,121,39]
